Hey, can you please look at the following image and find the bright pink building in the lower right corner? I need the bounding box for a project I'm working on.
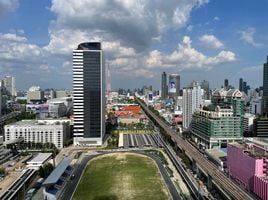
[227,144,268,200]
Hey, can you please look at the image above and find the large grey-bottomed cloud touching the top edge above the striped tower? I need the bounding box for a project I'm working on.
[50,0,208,51]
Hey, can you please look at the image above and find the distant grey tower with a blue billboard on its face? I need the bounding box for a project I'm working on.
[168,74,180,101]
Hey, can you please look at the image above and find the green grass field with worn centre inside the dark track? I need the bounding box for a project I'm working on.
[73,153,169,200]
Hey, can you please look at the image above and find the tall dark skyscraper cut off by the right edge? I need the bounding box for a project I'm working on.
[262,56,268,115]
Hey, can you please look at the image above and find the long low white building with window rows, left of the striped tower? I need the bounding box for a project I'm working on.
[4,119,70,149]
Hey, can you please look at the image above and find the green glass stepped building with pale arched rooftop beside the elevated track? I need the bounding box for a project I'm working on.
[190,89,244,149]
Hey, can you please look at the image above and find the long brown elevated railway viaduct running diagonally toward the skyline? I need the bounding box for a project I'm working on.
[137,99,254,200]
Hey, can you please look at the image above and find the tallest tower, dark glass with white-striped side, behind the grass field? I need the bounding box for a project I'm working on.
[73,42,105,146]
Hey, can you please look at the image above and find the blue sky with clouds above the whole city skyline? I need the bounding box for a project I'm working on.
[0,0,268,90]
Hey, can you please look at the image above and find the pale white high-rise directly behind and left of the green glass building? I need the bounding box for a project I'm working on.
[182,84,203,129]
